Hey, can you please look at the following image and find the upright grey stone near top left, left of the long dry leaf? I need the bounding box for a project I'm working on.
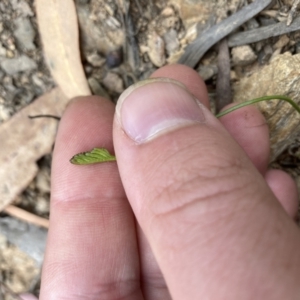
[14,17,35,50]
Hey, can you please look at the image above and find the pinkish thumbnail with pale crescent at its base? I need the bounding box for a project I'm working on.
[116,78,205,143]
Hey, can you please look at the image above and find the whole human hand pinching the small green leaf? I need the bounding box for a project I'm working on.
[25,65,300,300]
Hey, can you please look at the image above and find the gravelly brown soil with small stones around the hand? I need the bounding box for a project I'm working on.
[0,0,300,299]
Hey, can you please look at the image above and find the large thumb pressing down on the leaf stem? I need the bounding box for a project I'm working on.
[114,78,299,299]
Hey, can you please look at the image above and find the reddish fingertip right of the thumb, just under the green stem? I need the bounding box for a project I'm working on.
[220,104,270,175]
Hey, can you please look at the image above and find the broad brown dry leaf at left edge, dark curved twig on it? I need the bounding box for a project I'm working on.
[0,89,68,211]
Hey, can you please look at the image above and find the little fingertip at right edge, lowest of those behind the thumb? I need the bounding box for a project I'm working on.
[265,170,299,219]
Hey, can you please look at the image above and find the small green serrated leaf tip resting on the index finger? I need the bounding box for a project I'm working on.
[70,148,116,165]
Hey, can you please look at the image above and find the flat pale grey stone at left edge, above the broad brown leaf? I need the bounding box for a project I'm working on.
[0,55,37,75]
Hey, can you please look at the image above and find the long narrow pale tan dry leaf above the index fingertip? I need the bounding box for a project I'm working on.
[36,0,91,98]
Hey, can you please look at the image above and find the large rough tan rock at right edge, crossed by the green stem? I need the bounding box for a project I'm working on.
[234,53,300,161]
